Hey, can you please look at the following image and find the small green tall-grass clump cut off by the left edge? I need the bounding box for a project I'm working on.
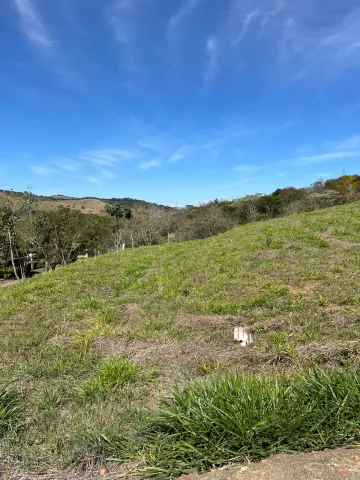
[0,387,22,438]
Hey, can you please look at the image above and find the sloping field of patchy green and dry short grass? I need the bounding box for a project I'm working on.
[0,202,360,468]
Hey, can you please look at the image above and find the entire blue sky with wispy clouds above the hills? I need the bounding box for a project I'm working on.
[0,0,360,206]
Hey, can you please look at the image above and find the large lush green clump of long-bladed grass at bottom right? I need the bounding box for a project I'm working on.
[136,369,360,477]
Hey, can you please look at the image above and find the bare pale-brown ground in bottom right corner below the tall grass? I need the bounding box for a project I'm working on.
[181,448,360,480]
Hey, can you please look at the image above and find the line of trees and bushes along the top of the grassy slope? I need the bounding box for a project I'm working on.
[0,175,360,279]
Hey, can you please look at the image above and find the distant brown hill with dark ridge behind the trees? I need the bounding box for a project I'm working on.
[0,190,171,215]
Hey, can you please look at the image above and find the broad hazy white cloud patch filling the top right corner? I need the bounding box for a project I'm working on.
[207,0,360,81]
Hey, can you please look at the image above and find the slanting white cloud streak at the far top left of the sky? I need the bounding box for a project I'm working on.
[13,0,54,51]
